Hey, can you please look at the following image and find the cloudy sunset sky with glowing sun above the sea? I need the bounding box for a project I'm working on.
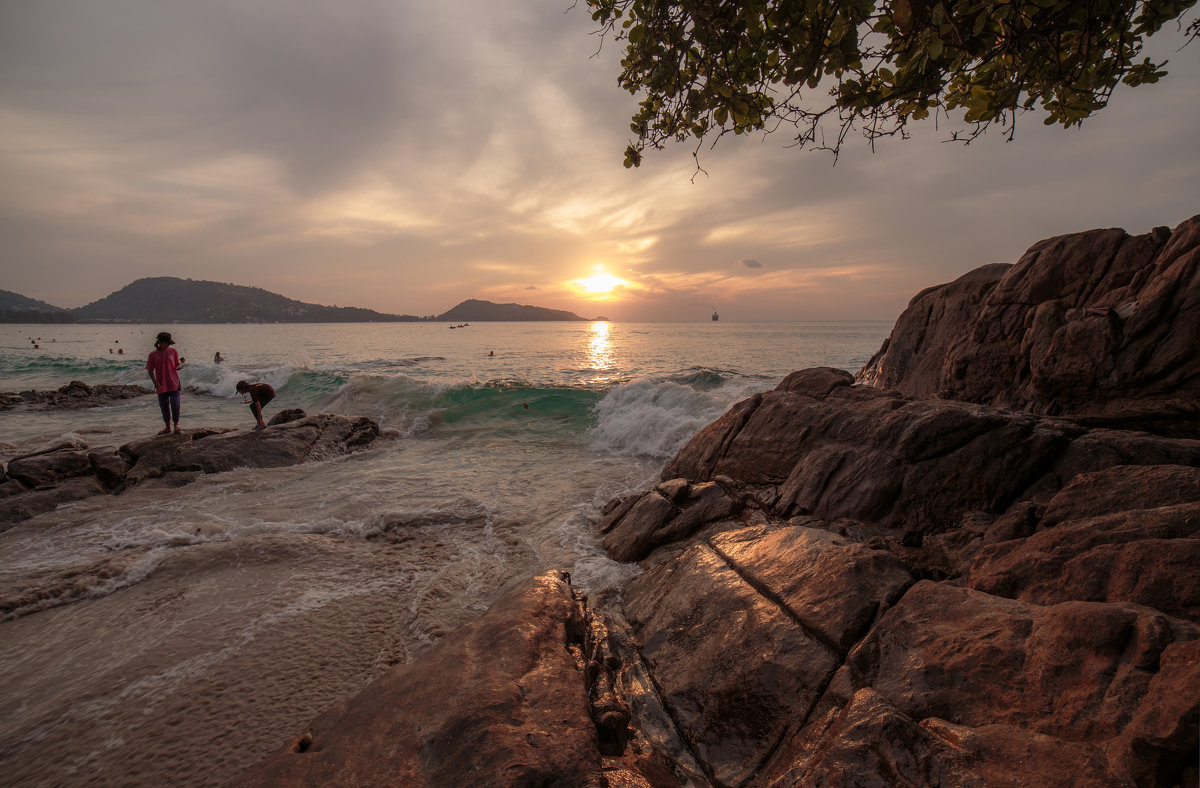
[0,0,1200,320]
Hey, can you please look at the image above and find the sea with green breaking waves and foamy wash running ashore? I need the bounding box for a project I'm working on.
[0,321,892,786]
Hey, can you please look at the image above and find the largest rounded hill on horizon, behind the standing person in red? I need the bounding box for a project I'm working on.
[71,276,419,323]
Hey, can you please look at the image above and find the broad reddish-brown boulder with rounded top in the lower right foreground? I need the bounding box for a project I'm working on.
[822,581,1200,744]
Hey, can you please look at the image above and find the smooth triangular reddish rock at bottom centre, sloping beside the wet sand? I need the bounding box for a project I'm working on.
[233,572,605,788]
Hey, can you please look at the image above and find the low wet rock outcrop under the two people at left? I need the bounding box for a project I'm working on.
[0,411,379,529]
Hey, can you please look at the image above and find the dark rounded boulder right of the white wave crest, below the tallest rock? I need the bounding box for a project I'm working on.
[662,386,1081,545]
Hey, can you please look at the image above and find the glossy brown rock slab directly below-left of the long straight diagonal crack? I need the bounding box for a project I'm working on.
[624,545,838,786]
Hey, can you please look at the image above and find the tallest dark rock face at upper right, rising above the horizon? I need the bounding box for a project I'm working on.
[859,216,1200,438]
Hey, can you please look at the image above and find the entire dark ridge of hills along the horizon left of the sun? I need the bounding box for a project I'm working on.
[0,276,607,323]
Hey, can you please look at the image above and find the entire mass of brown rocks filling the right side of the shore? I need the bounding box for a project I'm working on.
[238,217,1200,788]
